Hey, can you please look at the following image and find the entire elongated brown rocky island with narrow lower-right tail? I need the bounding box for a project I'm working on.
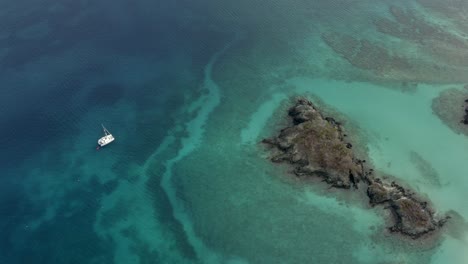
[262,98,447,239]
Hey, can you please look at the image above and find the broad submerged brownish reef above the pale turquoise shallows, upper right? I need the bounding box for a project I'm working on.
[321,6,468,83]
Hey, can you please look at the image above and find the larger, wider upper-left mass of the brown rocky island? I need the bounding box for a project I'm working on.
[263,99,363,188]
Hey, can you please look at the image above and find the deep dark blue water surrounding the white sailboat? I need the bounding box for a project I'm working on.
[0,1,224,263]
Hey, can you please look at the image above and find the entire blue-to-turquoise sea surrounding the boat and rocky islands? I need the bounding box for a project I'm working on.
[0,0,468,264]
